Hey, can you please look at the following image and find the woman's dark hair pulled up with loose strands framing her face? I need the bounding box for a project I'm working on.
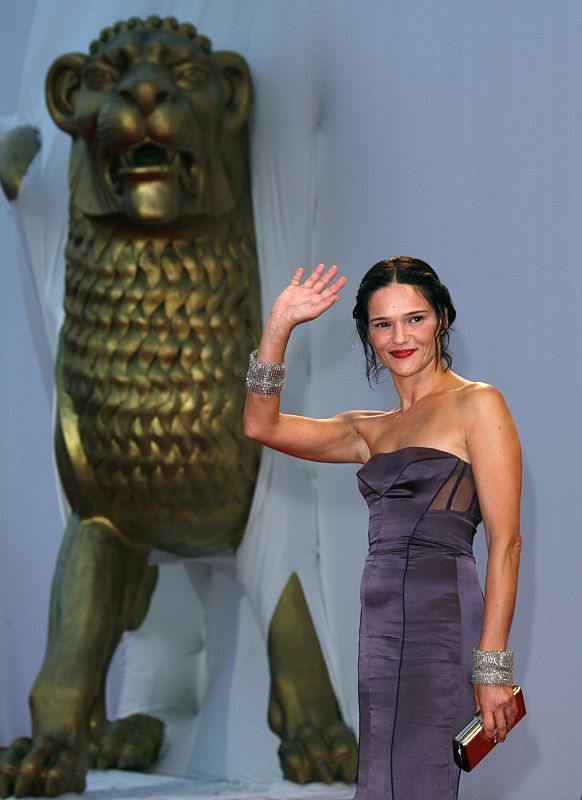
[353,256,457,381]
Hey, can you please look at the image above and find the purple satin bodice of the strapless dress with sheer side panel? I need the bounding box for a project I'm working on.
[358,447,481,557]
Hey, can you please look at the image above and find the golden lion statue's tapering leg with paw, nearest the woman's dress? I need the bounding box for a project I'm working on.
[269,573,357,783]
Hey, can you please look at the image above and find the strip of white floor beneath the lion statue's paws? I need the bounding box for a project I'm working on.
[57,770,354,800]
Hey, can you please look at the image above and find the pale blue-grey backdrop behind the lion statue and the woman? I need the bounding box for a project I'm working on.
[0,0,582,800]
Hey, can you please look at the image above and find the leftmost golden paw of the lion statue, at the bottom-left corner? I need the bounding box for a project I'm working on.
[0,736,87,797]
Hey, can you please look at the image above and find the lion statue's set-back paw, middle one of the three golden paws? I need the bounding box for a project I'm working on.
[89,714,164,771]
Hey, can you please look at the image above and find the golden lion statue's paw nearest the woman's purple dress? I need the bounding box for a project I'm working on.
[279,720,358,783]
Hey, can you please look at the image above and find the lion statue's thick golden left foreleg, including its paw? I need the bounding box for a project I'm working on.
[0,515,147,797]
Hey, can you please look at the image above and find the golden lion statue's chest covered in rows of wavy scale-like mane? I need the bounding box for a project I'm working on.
[61,225,259,524]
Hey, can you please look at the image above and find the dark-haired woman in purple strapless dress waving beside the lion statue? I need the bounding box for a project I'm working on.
[245,257,521,800]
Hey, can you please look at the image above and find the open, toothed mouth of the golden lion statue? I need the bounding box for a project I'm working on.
[109,143,197,191]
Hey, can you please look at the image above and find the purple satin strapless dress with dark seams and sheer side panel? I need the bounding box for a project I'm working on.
[355,447,483,800]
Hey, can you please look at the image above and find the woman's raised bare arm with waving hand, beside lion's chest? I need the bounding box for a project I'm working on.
[244,264,368,463]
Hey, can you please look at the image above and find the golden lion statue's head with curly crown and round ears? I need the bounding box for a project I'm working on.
[46,17,252,225]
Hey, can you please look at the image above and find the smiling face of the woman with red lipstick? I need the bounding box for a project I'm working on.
[368,283,438,377]
